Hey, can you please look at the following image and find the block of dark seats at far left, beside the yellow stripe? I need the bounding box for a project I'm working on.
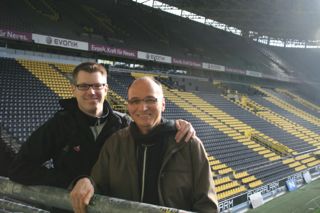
[0,58,60,143]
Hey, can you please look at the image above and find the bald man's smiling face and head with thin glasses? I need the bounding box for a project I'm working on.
[128,79,165,134]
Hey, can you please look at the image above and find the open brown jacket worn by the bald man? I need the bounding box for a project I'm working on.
[91,120,218,213]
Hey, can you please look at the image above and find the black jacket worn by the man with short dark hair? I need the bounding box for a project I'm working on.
[9,98,130,188]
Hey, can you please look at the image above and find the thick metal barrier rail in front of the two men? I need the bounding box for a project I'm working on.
[0,176,192,213]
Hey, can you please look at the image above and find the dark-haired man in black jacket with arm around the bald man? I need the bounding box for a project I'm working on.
[9,62,194,188]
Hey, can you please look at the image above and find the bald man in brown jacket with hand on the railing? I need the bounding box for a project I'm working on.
[70,77,218,213]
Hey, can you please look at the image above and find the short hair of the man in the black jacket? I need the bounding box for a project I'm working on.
[72,62,108,84]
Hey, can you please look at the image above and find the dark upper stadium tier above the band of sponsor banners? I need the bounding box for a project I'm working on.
[0,0,286,76]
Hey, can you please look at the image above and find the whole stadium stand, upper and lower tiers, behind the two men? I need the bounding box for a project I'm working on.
[0,0,320,212]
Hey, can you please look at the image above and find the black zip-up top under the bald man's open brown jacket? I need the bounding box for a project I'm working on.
[130,119,177,205]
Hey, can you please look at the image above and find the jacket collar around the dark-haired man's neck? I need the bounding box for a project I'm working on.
[59,98,113,126]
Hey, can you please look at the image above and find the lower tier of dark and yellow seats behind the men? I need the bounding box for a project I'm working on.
[0,58,320,211]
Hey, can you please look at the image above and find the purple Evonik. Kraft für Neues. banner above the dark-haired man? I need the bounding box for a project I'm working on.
[89,44,137,58]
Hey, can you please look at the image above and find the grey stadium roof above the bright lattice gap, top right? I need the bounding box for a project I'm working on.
[159,0,320,40]
